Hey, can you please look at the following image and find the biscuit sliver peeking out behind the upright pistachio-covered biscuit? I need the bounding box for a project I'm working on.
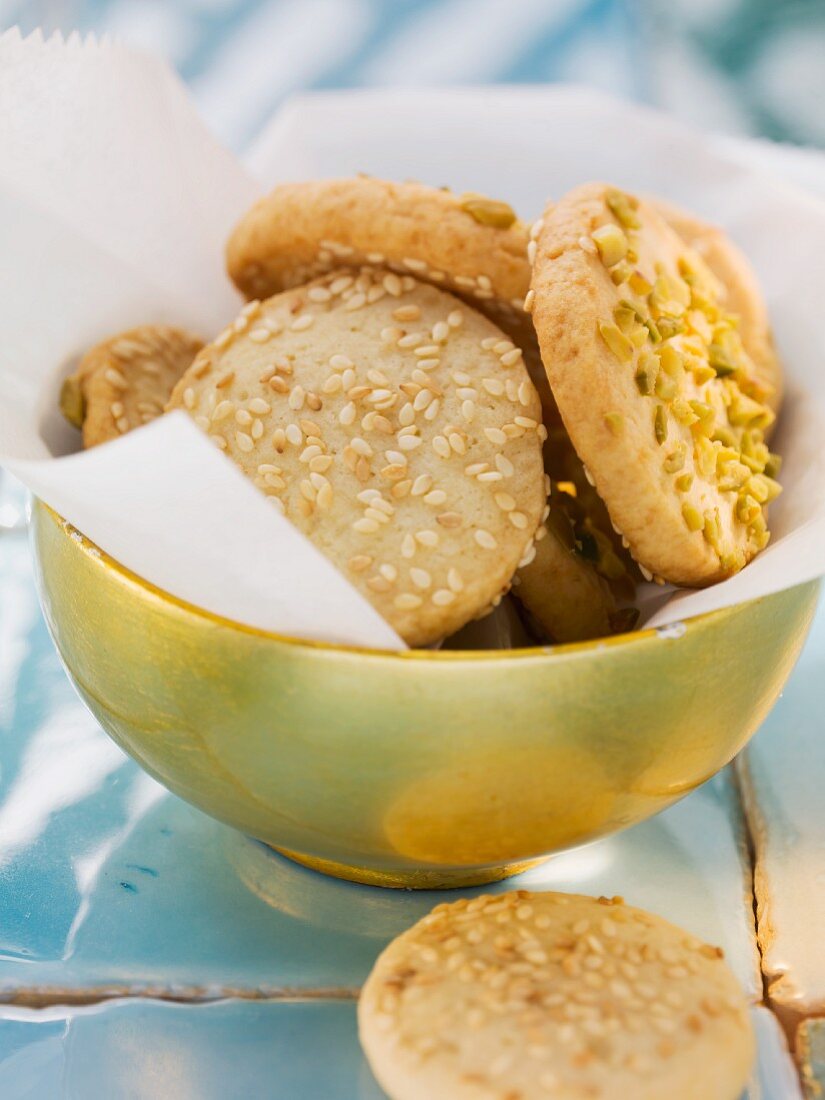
[652,199,783,413]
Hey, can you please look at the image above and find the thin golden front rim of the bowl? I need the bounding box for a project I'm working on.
[29,497,817,663]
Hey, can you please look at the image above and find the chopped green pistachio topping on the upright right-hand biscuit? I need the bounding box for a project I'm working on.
[592,184,781,573]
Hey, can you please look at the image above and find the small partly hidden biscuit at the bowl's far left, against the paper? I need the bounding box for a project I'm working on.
[61,325,204,448]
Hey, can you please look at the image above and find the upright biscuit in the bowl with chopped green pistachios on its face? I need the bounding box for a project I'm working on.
[532,184,780,586]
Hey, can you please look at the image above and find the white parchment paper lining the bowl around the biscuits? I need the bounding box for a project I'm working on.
[0,32,825,648]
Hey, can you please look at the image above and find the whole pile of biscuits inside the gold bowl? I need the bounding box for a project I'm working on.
[61,177,782,646]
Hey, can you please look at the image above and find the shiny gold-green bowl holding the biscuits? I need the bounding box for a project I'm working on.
[32,504,818,887]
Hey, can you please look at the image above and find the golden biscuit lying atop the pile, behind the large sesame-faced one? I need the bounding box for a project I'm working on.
[227,176,530,337]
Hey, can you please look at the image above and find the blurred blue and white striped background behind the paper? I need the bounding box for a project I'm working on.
[0,0,825,149]
